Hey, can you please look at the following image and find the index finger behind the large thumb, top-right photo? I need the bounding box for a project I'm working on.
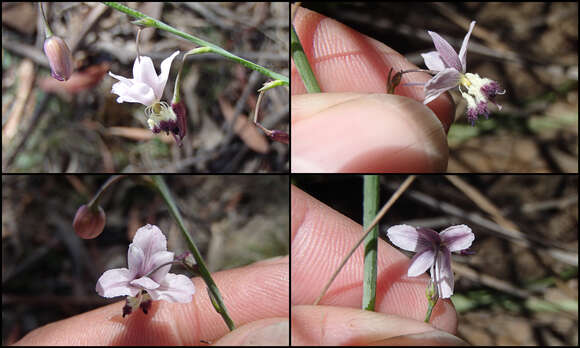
[291,8,454,131]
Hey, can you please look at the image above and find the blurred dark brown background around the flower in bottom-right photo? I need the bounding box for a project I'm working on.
[292,175,578,346]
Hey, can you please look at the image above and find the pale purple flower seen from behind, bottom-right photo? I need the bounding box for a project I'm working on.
[387,225,475,298]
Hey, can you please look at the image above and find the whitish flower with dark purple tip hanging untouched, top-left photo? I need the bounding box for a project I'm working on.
[109,51,185,139]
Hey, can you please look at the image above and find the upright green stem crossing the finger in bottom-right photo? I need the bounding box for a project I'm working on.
[362,175,379,311]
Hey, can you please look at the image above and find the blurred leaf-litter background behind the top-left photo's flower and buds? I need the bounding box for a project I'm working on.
[2,2,289,173]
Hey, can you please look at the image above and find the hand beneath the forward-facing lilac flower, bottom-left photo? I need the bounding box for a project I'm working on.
[11,256,289,346]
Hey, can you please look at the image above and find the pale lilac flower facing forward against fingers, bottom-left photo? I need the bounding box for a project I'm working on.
[96,225,195,316]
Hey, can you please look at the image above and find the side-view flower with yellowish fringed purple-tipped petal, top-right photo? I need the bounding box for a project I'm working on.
[421,21,505,125]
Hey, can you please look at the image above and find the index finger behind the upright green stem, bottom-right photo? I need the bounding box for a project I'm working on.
[291,187,457,333]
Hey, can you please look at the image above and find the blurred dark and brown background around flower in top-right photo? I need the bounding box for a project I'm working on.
[302,1,578,173]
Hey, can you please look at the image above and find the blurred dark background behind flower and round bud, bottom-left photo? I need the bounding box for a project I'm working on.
[2,175,290,345]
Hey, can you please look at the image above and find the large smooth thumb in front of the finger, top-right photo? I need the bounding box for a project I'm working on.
[291,93,449,173]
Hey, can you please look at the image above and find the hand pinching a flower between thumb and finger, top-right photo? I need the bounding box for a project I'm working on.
[291,8,454,172]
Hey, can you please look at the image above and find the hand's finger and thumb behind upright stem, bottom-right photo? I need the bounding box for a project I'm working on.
[291,187,465,345]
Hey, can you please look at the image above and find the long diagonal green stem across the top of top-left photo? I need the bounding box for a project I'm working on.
[104,2,290,86]
